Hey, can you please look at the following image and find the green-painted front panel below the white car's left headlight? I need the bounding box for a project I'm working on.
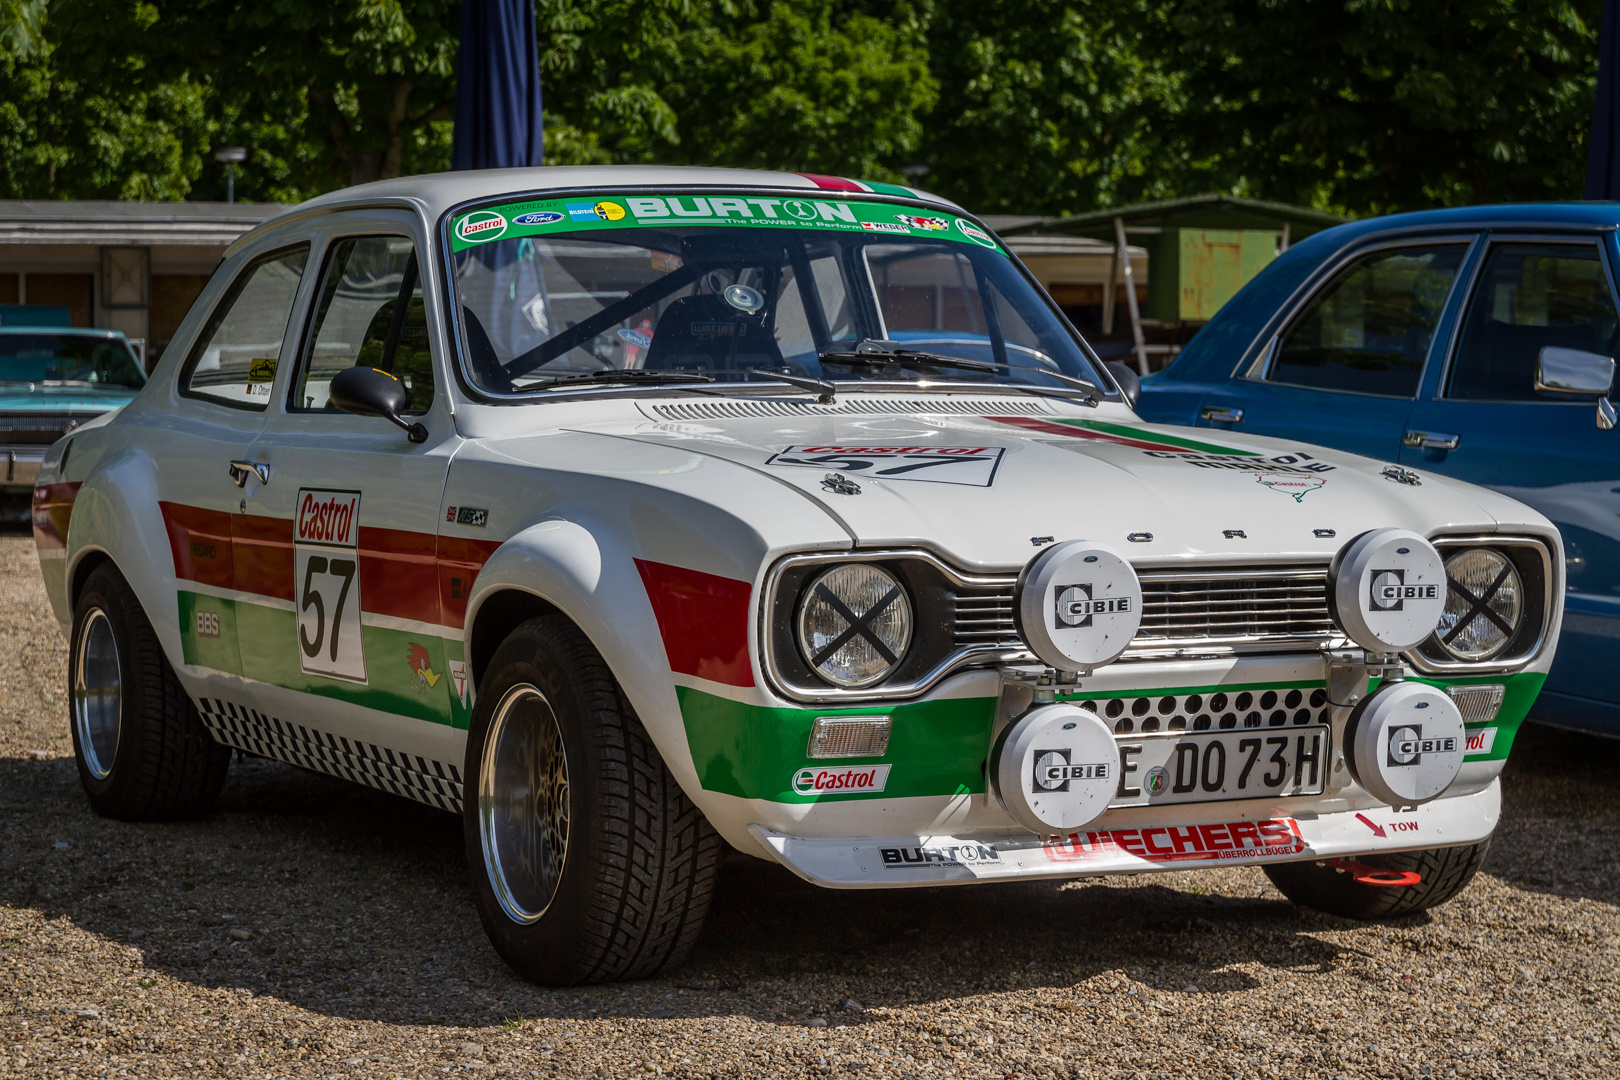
[676,687,996,803]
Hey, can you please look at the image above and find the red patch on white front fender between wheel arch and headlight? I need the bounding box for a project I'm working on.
[635,559,753,687]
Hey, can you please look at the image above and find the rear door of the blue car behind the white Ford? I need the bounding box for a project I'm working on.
[1197,238,1469,460]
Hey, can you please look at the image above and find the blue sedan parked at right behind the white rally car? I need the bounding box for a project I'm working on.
[1137,202,1620,737]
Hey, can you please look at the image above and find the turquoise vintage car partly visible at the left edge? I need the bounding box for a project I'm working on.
[0,324,146,513]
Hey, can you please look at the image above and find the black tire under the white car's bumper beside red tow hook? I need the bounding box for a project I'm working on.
[1265,837,1490,920]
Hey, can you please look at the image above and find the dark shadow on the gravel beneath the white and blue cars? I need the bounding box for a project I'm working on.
[0,712,1620,1027]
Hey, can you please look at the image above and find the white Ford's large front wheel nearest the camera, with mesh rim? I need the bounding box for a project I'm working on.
[462,615,721,986]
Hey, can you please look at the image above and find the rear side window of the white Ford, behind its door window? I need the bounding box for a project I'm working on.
[180,246,309,410]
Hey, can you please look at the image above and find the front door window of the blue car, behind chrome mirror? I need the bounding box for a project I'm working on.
[1447,243,1620,402]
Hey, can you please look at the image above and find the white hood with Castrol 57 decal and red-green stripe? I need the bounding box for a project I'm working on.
[573,395,1497,570]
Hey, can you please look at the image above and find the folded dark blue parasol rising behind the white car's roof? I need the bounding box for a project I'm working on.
[450,0,544,168]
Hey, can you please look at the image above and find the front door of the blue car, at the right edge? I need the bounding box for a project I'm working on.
[1401,235,1620,725]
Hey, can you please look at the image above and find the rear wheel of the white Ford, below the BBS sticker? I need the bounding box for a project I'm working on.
[68,562,230,821]
